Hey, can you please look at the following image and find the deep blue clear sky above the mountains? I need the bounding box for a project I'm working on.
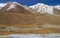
[0,0,60,6]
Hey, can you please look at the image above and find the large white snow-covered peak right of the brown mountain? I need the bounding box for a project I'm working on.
[29,3,53,14]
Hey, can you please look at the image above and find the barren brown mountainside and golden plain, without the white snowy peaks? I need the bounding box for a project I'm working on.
[0,3,60,35]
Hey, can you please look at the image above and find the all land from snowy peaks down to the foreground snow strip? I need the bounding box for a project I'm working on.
[0,2,60,33]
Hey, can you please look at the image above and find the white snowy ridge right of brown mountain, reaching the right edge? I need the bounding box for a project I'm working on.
[29,3,60,14]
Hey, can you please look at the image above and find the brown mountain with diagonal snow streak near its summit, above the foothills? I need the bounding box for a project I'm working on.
[0,2,36,13]
